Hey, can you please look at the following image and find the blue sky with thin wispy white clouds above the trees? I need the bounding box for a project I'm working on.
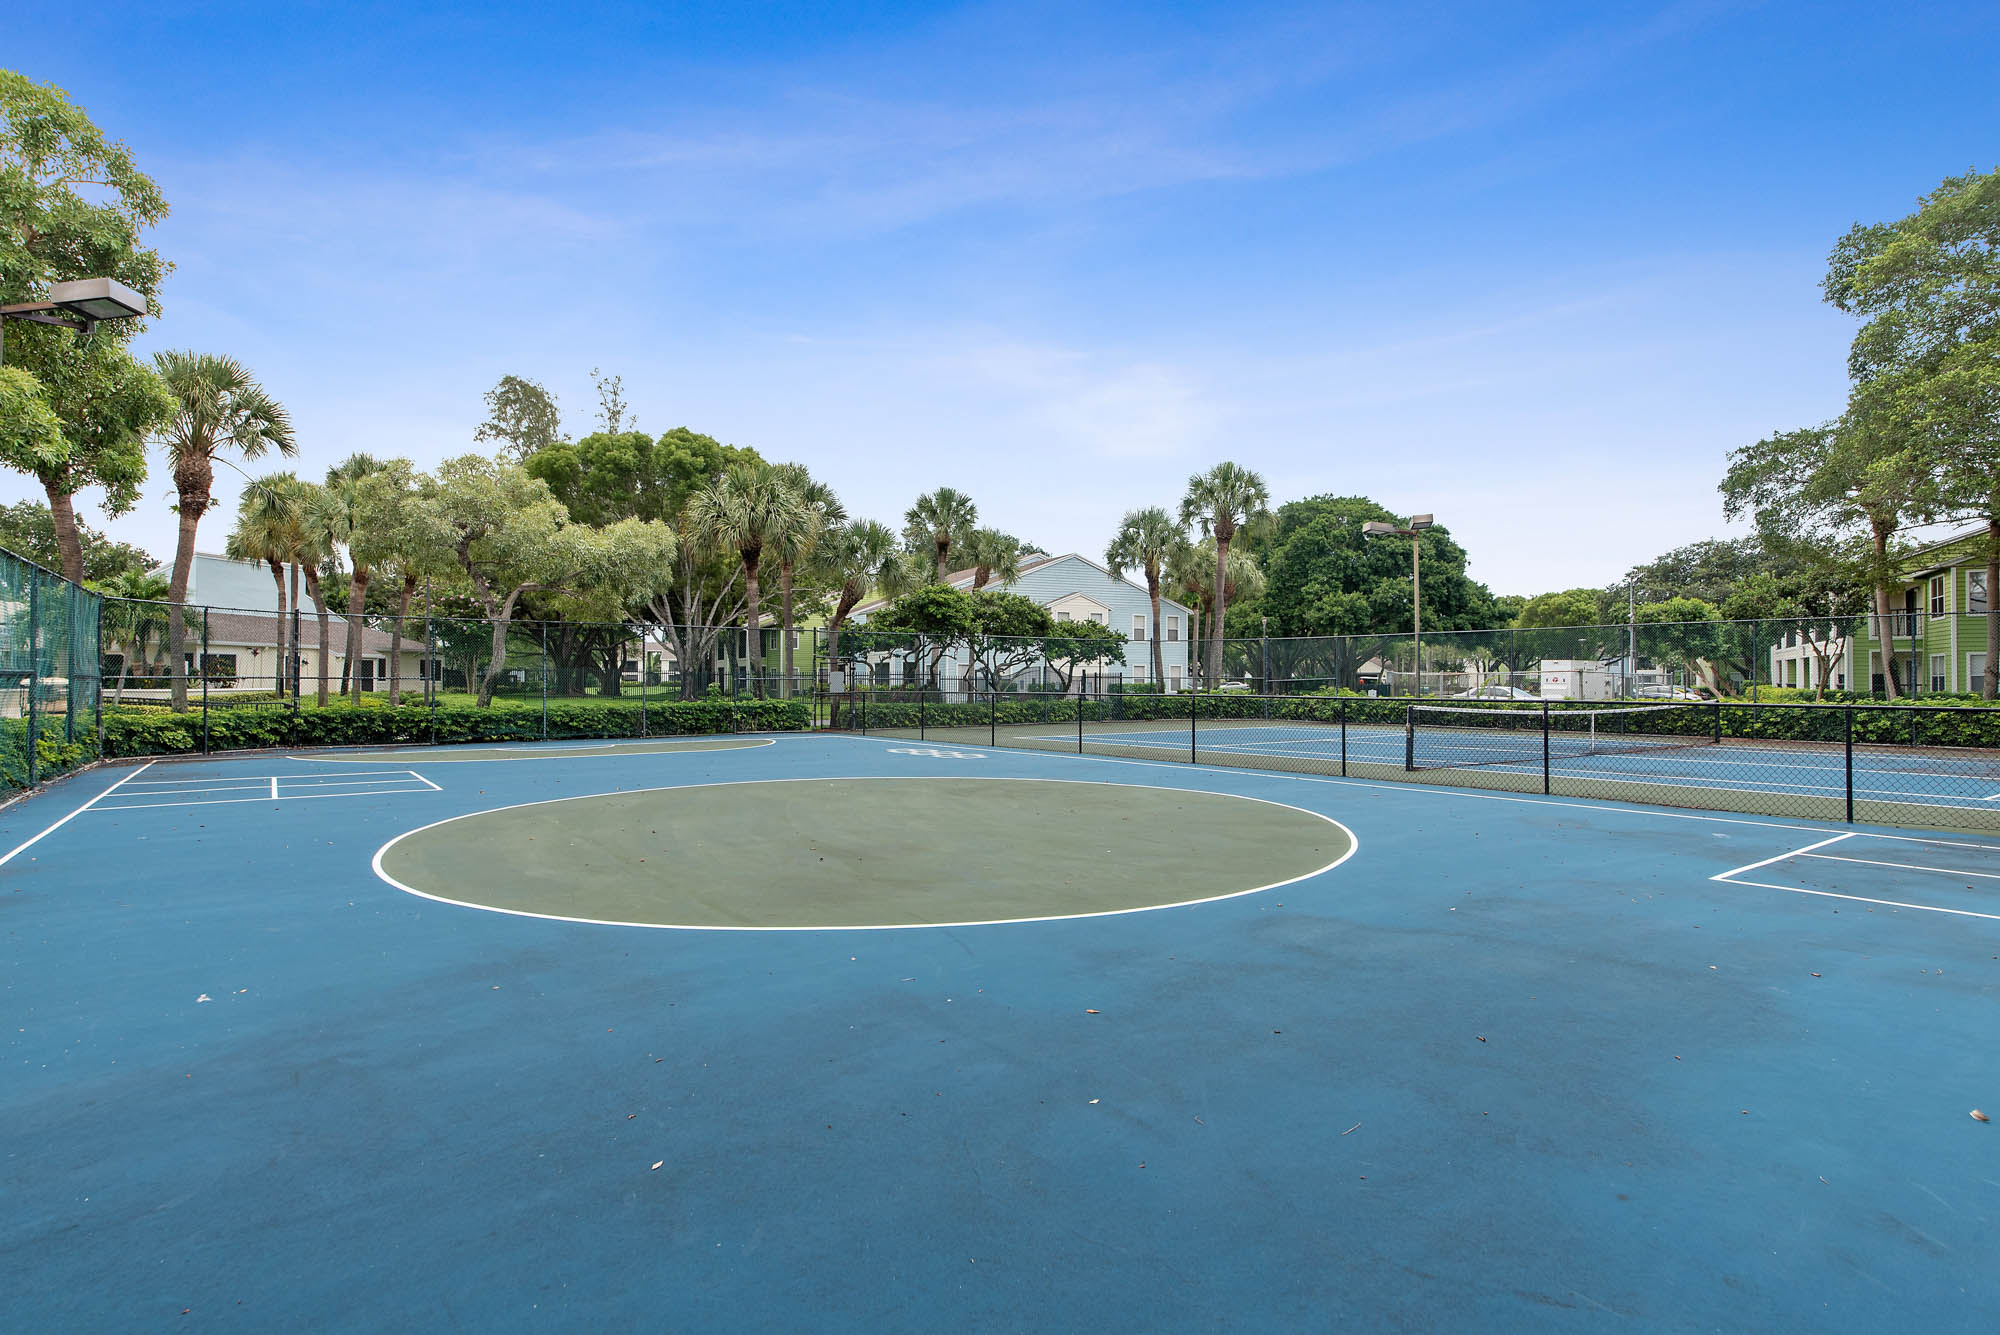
[0,2,2000,594]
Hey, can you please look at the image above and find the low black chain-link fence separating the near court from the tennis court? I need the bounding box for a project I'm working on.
[828,691,2000,831]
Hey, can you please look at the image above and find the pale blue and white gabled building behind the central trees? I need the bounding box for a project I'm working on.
[852,552,1192,691]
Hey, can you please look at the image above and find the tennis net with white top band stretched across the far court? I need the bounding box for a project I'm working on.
[1406,703,1720,769]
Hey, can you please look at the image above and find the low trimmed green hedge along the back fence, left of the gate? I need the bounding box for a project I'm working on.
[104,699,812,755]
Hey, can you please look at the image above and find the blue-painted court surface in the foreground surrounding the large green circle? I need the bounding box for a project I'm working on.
[0,735,2000,1333]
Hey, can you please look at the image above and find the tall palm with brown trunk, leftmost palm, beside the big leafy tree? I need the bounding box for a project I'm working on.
[154,352,298,711]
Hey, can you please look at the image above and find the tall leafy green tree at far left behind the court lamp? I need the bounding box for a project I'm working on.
[0,70,170,582]
